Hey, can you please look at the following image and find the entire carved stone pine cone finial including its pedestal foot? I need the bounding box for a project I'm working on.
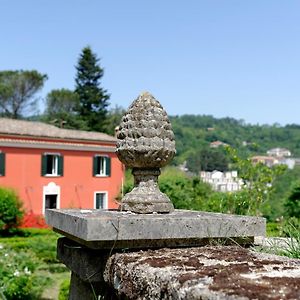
[116,93,176,213]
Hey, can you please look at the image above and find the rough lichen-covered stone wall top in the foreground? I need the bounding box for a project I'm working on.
[104,246,300,300]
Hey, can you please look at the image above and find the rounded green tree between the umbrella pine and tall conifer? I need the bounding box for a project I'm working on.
[44,89,88,130]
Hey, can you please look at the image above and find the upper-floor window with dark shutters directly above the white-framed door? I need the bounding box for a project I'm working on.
[42,153,63,176]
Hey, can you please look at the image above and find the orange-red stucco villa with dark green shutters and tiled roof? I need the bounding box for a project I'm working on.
[0,118,124,225]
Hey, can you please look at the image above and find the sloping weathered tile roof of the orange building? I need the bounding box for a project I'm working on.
[0,118,116,143]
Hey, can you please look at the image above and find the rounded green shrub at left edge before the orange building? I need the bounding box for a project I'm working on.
[0,187,23,233]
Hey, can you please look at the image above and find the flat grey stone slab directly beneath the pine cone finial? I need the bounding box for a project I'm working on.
[45,209,266,249]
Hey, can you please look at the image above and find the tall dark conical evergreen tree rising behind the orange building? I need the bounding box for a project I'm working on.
[75,47,109,131]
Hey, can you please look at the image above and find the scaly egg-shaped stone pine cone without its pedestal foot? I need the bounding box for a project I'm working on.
[116,93,176,168]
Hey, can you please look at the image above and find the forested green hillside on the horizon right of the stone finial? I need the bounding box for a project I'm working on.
[170,115,300,164]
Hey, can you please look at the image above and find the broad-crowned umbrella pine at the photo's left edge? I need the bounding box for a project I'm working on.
[0,70,47,118]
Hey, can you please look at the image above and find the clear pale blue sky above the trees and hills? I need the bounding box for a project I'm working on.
[0,0,300,124]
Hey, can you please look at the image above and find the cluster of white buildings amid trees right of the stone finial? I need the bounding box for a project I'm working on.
[200,170,243,192]
